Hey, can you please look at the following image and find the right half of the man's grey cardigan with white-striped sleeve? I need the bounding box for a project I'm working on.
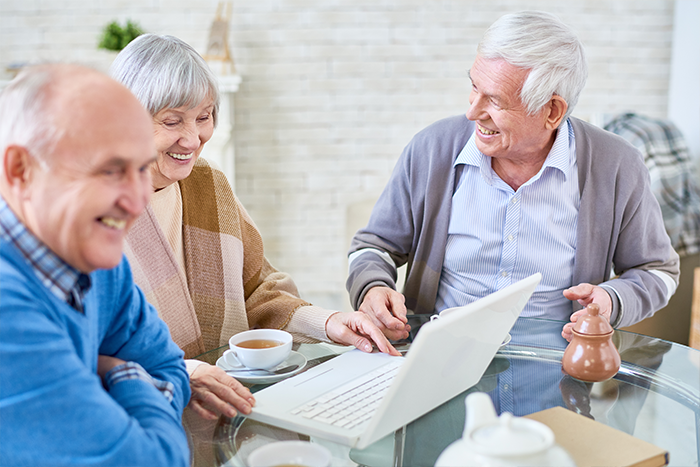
[571,118,680,327]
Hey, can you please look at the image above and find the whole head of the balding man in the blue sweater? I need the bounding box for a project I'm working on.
[0,65,155,272]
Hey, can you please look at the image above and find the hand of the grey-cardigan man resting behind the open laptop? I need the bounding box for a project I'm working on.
[359,287,411,340]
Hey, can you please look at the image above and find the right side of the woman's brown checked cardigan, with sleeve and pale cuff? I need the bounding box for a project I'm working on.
[180,158,338,348]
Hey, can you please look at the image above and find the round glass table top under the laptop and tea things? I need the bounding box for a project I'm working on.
[183,316,700,467]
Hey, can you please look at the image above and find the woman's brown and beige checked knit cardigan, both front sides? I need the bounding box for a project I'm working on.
[125,158,317,358]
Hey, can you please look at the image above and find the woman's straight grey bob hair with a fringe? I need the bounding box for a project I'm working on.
[109,34,219,125]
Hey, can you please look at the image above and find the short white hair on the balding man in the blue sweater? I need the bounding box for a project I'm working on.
[0,65,64,162]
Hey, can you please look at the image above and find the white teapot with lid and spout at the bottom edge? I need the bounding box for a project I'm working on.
[435,392,576,467]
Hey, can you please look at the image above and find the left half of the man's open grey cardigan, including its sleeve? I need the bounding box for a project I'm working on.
[346,114,464,313]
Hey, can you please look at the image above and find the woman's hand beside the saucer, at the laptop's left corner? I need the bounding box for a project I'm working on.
[188,363,255,420]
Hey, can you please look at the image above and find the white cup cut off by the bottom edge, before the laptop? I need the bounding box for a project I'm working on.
[248,441,333,467]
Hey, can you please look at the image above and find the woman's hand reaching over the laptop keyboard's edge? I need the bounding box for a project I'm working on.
[326,311,401,356]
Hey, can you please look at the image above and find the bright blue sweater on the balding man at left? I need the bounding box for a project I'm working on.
[0,240,190,467]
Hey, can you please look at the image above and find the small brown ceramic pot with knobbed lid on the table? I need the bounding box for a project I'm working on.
[561,303,620,383]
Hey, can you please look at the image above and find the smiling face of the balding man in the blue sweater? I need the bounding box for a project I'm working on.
[13,73,155,272]
